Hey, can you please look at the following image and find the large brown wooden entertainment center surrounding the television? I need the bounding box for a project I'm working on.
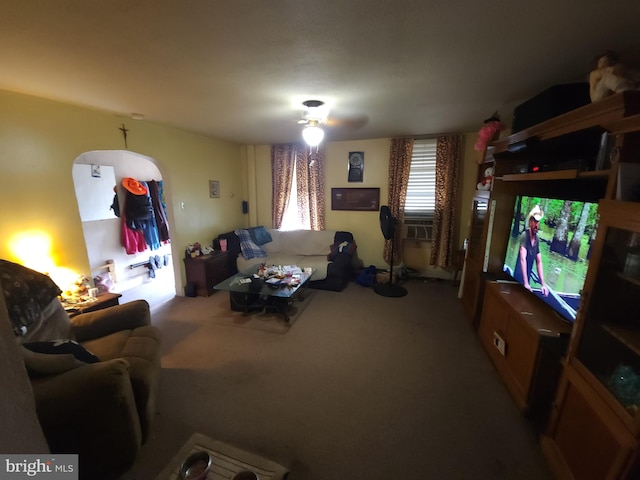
[461,91,640,480]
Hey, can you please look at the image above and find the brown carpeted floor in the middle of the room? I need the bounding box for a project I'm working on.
[121,280,552,480]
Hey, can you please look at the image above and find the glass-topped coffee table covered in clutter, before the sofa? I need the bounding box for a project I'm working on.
[213,264,313,322]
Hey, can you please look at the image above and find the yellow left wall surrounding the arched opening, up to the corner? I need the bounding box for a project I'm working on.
[0,91,247,288]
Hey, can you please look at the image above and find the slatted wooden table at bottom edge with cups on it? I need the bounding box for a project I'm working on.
[156,433,288,480]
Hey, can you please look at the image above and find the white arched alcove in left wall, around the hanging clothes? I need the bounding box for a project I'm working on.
[72,150,178,306]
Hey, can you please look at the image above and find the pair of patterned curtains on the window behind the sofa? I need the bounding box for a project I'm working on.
[271,144,325,230]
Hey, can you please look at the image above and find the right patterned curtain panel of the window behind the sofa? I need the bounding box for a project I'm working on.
[296,145,325,230]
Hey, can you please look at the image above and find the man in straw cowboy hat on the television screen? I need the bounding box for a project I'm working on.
[513,205,549,297]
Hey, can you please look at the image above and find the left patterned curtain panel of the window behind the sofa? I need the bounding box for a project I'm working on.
[271,144,297,229]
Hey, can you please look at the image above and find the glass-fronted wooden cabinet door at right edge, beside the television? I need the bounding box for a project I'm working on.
[572,201,640,434]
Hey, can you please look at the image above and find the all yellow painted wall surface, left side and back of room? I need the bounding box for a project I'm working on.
[0,86,477,284]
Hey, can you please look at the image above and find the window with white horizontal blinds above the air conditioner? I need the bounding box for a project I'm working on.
[404,138,438,224]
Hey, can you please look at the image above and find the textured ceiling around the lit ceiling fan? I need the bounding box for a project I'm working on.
[0,0,640,144]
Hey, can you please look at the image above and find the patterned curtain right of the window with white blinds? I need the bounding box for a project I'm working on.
[429,135,461,267]
